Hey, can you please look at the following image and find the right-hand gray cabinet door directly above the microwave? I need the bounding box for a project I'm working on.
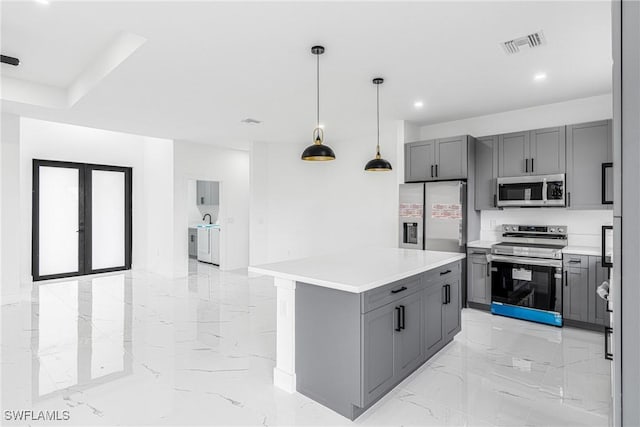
[529,126,566,175]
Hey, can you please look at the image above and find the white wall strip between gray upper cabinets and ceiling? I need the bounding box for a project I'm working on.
[416,94,613,142]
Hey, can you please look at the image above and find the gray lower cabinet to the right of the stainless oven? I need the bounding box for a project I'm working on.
[562,255,609,329]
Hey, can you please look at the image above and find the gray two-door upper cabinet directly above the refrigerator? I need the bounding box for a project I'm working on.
[404,135,469,182]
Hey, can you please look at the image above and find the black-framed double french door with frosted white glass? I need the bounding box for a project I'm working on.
[31,159,132,281]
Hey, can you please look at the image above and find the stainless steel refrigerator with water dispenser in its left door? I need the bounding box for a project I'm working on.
[399,181,467,252]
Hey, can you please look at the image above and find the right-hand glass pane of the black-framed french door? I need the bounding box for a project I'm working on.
[91,170,125,270]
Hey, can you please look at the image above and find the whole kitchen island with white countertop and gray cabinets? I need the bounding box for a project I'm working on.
[249,248,465,420]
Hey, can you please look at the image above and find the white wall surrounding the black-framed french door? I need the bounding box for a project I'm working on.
[16,117,174,281]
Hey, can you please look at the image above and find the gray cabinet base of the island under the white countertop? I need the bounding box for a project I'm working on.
[295,261,462,420]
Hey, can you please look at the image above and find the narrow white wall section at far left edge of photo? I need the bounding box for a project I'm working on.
[0,113,21,303]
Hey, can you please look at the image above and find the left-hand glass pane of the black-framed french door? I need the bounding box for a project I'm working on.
[38,166,79,276]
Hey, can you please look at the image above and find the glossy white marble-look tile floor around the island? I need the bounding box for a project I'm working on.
[1,263,610,426]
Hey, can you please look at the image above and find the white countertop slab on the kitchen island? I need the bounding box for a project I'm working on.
[249,248,466,293]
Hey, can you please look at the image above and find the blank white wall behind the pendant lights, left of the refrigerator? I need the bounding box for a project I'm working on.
[251,122,398,265]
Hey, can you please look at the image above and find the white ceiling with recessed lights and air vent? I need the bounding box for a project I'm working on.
[1,0,612,148]
